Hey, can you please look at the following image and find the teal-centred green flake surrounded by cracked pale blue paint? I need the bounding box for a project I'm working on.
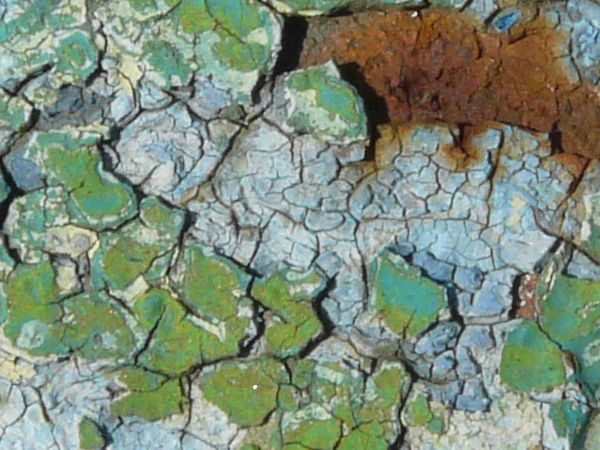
[371,252,446,336]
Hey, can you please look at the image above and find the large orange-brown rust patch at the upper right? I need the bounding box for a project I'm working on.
[301,9,600,160]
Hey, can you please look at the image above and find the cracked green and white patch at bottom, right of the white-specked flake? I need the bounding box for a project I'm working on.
[283,360,410,448]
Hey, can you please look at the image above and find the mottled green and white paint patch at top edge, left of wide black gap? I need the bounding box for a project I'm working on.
[101,0,281,103]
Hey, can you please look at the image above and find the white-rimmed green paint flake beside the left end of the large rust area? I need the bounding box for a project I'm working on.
[284,63,367,143]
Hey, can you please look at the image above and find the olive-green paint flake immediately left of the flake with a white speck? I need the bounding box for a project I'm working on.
[111,368,187,421]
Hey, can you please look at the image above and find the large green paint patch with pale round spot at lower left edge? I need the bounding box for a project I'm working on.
[4,262,134,360]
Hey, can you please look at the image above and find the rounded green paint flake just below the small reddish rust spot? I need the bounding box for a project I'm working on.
[500,321,565,392]
